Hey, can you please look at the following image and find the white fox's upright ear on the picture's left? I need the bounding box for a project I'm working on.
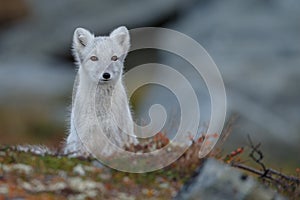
[73,28,94,50]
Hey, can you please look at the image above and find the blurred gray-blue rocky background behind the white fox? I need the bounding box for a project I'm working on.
[0,0,300,169]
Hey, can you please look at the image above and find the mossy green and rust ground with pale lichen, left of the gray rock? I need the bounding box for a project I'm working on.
[0,138,201,199]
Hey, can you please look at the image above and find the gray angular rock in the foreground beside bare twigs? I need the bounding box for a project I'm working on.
[175,159,285,200]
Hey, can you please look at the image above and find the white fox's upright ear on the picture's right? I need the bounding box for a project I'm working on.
[109,26,130,54]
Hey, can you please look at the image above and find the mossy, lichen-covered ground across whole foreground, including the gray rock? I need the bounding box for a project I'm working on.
[0,136,300,200]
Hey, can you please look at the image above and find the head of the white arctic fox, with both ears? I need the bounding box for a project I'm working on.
[73,26,130,84]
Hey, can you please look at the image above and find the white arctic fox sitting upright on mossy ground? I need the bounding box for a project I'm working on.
[64,26,137,156]
